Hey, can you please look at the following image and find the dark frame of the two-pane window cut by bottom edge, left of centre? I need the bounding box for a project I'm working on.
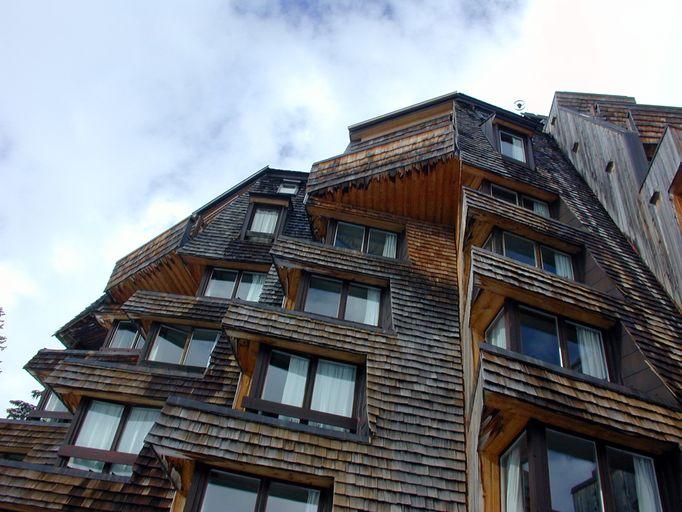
[183,464,332,512]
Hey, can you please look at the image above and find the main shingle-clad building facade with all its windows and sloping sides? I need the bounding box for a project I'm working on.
[0,93,682,512]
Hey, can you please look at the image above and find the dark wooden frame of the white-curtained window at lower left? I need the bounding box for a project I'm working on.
[57,398,161,474]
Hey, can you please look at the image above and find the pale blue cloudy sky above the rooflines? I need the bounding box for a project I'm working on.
[0,0,682,410]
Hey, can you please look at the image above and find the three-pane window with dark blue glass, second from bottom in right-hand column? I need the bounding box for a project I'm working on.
[485,302,609,380]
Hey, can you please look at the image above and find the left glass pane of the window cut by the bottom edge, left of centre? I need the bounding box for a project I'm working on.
[201,471,260,512]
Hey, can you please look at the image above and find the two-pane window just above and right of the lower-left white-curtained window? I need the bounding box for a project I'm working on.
[147,325,220,368]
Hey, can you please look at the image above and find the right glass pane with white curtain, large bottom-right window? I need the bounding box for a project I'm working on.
[606,448,661,512]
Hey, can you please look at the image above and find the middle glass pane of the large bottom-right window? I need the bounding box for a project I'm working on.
[547,430,602,512]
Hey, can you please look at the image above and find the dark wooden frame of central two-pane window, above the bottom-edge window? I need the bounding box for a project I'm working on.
[241,345,366,434]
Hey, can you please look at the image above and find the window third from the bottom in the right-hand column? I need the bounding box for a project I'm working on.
[483,230,575,280]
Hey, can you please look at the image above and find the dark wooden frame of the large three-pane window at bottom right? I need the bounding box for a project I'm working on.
[497,420,669,512]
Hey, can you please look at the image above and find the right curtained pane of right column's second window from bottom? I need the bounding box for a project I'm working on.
[566,322,608,379]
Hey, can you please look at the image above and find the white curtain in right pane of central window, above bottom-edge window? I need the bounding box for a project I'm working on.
[310,359,355,418]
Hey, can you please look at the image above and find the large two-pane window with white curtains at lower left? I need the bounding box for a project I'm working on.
[60,400,160,475]
